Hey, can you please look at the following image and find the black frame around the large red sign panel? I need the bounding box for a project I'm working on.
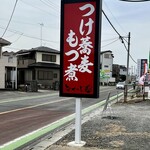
[59,0,101,98]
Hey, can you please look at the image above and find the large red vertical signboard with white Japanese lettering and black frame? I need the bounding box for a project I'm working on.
[60,0,101,98]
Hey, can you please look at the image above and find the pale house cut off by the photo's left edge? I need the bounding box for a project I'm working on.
[0,38,17,89]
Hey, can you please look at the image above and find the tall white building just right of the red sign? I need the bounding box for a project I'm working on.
[100,50,115,84]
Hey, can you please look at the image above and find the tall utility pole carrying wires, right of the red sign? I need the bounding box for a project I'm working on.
[124,32,131,102]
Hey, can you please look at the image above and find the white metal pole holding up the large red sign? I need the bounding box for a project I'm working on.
[75,98,82,144]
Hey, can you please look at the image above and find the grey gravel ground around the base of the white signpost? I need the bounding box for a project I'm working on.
[47,99,150,150]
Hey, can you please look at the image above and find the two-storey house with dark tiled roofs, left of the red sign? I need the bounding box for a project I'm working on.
[16,46,60,88]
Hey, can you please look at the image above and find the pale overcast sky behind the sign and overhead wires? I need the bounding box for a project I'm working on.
[0,0,150,70]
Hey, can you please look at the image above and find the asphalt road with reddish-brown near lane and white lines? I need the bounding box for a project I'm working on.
[0,86,122,146]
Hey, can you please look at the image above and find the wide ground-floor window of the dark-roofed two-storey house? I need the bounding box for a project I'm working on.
[38,70,53,80]
